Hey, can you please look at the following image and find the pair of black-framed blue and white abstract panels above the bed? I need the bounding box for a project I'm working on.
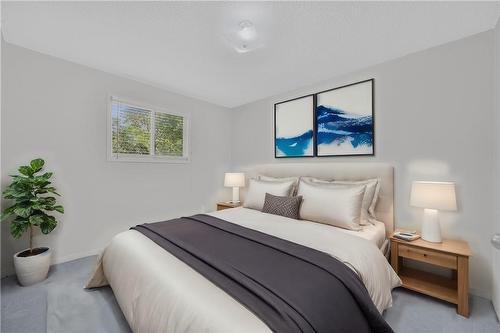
[274,79,375,157]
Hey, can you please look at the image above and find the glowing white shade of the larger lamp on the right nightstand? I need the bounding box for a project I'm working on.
[410,181,457,210]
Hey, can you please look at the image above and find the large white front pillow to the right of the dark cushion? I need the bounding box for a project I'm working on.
[297,180,366,230]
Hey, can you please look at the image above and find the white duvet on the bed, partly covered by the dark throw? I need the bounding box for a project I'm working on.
[87,208,401,332]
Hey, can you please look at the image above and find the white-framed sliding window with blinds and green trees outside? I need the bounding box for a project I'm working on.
[108,97,189,162]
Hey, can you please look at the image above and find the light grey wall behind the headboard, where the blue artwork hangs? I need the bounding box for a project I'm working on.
[232,31,495,297]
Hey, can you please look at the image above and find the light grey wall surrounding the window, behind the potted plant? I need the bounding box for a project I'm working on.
[1,43,230,276]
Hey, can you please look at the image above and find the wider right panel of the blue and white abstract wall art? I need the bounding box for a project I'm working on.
[316,80,374,156]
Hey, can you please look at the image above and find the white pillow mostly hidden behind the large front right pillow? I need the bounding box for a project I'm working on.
[308,178,380,225]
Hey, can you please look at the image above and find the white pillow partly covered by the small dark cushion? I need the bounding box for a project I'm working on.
[243,179,295,210]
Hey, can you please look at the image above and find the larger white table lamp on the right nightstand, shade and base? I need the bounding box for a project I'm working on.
[410,181,457,243]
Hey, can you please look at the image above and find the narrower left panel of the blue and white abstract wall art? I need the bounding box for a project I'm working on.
[274,95,314,157]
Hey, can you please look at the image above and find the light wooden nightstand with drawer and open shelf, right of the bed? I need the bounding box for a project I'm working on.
[391,233,471,317]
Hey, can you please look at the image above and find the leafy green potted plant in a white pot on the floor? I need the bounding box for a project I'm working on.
[1,158,64,286]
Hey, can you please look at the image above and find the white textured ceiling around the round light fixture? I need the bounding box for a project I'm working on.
[2,2,500,107]
